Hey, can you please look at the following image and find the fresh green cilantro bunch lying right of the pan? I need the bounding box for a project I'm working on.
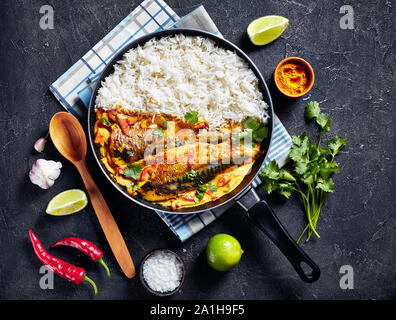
[261,101,346,243]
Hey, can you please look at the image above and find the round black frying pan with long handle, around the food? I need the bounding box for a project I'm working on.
[88,29,320,282]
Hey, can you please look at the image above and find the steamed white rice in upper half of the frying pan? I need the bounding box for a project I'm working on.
[96,35,269,126]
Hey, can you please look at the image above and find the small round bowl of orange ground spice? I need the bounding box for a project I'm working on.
[274,57,315,98]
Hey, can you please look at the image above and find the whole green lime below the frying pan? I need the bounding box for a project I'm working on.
[206,233,243,271]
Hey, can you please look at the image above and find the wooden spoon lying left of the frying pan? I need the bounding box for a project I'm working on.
[49,112,135,278]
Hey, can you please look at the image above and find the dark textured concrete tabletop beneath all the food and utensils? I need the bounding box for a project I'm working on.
[0,0,396,299]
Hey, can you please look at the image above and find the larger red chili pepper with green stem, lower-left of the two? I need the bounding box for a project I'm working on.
[29,230,98,296]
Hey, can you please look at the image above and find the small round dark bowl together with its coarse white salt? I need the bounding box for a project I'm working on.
[139,249,186,297]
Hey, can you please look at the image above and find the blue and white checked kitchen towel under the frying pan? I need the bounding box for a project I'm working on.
[50,0,291,242]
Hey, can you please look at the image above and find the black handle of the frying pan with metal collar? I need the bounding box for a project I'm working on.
[237,188,320,282]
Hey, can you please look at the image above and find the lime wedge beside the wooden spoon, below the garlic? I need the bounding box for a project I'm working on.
[45,189,88,216]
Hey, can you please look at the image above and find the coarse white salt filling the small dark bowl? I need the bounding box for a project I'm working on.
[142,251,183,293]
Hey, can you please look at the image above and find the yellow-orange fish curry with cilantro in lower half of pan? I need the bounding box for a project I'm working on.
[94,108,260,210]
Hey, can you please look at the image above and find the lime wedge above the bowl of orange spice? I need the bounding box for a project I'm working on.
[246,16,289,46]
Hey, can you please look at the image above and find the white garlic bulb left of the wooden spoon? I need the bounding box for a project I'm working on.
[29,159,62,189]
